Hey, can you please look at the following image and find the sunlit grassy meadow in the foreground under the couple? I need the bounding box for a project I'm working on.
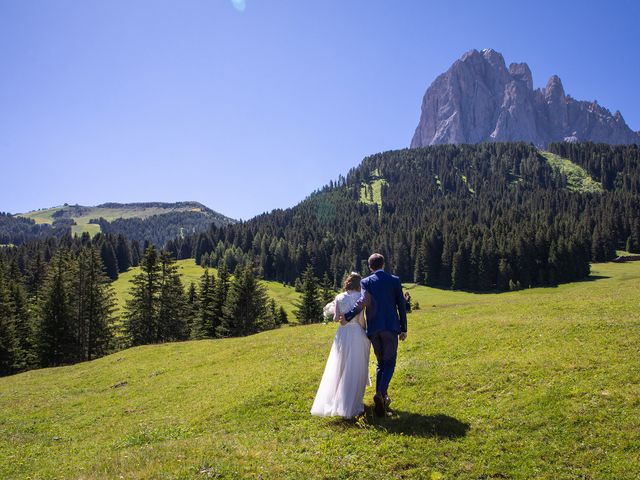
[0,262,640,480]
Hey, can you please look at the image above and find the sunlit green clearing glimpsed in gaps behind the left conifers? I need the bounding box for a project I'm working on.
[112,259,300,322]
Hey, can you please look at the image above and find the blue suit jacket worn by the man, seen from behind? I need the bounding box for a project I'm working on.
[344,270,407,336]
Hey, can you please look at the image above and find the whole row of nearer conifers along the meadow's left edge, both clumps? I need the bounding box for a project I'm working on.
[0,235,288,375]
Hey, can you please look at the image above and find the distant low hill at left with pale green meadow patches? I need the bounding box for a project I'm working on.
[18,202,235,246]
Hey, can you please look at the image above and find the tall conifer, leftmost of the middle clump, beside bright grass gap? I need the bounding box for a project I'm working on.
[124,245,160,345]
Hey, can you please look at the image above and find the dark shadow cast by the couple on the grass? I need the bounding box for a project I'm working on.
[331,406,471,439]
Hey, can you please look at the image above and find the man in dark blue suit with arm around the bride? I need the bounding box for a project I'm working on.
[339,253,407,416]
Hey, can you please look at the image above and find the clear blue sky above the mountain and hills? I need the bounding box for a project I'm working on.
[0,0,640,219]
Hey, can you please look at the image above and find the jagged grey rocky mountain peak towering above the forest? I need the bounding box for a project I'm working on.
[411,49,640,148]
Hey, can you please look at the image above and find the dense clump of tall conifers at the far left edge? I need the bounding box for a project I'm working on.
[0,246,114,375]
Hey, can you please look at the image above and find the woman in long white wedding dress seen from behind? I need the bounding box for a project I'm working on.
[311,273,371,418]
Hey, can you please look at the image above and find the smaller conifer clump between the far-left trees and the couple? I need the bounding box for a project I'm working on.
[123,245,288,345]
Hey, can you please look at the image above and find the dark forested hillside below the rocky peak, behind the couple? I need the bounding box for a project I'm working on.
[167,143,640,291]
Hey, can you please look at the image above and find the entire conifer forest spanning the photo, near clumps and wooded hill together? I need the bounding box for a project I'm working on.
[0,143,640,374]
